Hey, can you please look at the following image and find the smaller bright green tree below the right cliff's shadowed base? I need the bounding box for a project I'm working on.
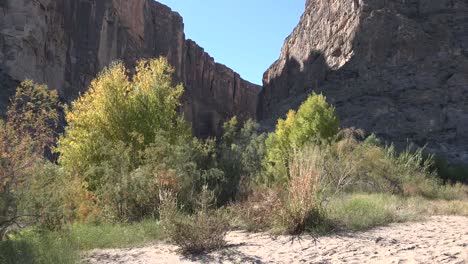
[261,94,339,184]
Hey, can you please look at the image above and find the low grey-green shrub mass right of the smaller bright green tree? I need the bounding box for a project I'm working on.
[325,135,462,198]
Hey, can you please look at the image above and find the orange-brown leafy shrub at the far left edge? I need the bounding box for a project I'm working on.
[0,81,60,239]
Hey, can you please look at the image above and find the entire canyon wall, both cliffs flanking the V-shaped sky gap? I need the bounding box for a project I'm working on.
[0,0,468,162]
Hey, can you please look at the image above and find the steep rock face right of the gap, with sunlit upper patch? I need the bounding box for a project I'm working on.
[258,0,468,162]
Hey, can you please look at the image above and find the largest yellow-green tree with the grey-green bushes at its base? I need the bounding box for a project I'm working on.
[57,58,223,221]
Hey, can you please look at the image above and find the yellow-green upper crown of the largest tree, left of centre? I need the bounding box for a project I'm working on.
[57,58,190,187]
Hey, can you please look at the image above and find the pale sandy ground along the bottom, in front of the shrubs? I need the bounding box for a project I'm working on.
[86,216,468,264]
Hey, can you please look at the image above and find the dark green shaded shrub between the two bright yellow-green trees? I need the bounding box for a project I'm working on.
[216,117,266,205]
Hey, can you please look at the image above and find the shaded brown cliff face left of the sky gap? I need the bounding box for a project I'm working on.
[0,0,260,136]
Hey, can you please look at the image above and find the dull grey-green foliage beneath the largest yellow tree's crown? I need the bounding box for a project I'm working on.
[90,132,223,221]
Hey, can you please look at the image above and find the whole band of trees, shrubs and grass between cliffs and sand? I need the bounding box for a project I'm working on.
[0,54,467,260]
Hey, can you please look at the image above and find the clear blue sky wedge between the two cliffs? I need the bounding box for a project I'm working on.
[158,0,305,84]
